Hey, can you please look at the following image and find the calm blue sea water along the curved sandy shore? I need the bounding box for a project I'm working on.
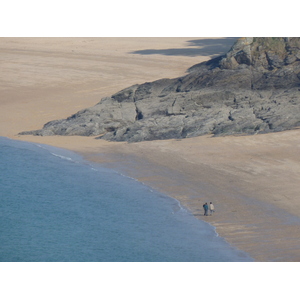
[0,137,253,262]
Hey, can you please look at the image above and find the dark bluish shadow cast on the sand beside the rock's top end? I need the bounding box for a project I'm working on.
[130,37,238,58]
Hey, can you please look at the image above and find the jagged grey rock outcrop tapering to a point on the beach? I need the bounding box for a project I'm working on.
[21,38,300,142]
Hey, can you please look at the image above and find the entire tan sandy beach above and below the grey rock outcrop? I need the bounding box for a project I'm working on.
[0,38,300,261]
